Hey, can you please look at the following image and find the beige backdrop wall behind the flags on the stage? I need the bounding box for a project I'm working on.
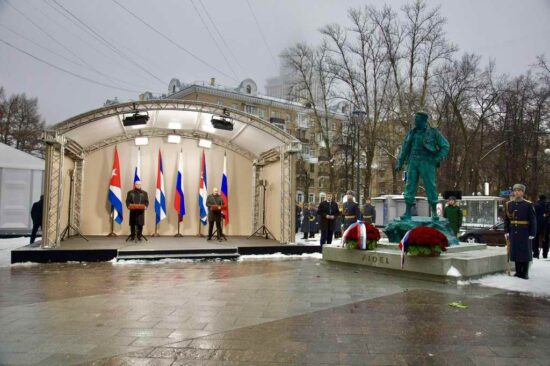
[80,137,256,235]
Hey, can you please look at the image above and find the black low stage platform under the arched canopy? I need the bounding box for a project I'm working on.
[11,236,321,263]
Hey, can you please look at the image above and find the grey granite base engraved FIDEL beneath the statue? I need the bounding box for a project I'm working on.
[323,241,508,282]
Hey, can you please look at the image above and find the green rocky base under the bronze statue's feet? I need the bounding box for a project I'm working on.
[384,216,459,245]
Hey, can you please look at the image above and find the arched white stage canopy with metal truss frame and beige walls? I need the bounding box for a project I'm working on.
[42,100,301,247]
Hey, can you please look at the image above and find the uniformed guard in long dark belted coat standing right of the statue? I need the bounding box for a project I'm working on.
[504,184,537,279]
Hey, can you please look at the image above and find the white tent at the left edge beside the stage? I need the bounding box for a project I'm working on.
[0,143,44,235]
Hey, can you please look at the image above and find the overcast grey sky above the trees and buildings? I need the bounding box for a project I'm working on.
[0,0,550,124]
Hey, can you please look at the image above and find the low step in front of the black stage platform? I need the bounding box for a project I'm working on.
[117,249,239,261]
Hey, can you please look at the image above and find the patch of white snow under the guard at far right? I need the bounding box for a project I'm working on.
[468,259,550,296]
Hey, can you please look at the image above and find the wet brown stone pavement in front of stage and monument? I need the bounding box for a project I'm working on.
[0,258,550,365]
